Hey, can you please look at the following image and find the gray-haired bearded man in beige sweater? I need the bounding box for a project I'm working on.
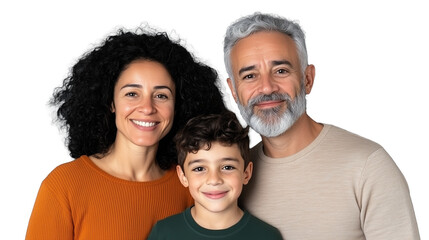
[224,13,420,240]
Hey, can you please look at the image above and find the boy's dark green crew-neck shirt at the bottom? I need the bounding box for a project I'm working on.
[148,208,283,240]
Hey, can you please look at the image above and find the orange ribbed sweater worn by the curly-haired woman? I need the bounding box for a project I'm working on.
[26,156,193,240]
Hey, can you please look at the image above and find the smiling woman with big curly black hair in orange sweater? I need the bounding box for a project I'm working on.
[26,26,225,239]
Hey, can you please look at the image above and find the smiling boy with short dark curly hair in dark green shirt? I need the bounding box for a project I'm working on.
[149,112,282,240]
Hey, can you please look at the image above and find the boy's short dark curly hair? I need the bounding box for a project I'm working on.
[174,110,250,169]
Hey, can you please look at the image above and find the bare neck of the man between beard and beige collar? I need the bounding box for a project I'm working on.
[261,113,323,158]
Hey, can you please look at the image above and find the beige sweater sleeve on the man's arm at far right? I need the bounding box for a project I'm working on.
[361,148,420,240]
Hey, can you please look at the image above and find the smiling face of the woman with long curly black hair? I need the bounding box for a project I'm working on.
[112,60,176,146]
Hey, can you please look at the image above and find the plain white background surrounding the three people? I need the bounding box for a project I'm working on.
[0,0,429,239]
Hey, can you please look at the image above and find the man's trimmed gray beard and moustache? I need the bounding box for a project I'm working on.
[237,88,307,137]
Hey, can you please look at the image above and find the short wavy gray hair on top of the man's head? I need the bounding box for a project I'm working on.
[223,12,308,82]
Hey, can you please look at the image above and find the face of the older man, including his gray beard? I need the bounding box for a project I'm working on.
[228,31,307,137]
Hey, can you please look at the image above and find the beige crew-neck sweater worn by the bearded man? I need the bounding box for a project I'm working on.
[241,124,420,240]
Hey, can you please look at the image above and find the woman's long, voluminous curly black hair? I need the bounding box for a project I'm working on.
[50,27,226,169]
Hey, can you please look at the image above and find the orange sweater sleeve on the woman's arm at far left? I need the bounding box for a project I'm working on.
[25,181,73,240]
